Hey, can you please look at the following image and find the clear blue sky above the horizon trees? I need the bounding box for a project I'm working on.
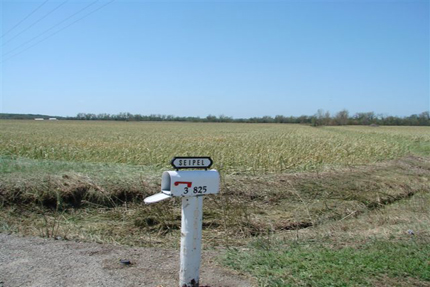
[0,0,430,118]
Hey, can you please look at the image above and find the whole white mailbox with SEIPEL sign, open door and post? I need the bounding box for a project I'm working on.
[144,157,220,287]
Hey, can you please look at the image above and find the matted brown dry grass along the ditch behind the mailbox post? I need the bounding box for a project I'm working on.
[0,156,430,248]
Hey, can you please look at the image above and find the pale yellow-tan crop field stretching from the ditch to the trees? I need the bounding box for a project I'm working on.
[0,121,430,174]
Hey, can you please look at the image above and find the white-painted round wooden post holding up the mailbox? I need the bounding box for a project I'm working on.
[179,196,203,287]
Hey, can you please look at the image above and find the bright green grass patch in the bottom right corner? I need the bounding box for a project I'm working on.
[223,240,430,287]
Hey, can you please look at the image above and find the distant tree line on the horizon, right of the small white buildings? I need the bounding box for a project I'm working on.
[66,109,430,126]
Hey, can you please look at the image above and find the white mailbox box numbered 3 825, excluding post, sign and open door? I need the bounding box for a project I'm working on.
[161,169,220,197]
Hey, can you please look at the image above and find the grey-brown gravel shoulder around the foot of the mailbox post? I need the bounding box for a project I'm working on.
[0,234,253,287]
